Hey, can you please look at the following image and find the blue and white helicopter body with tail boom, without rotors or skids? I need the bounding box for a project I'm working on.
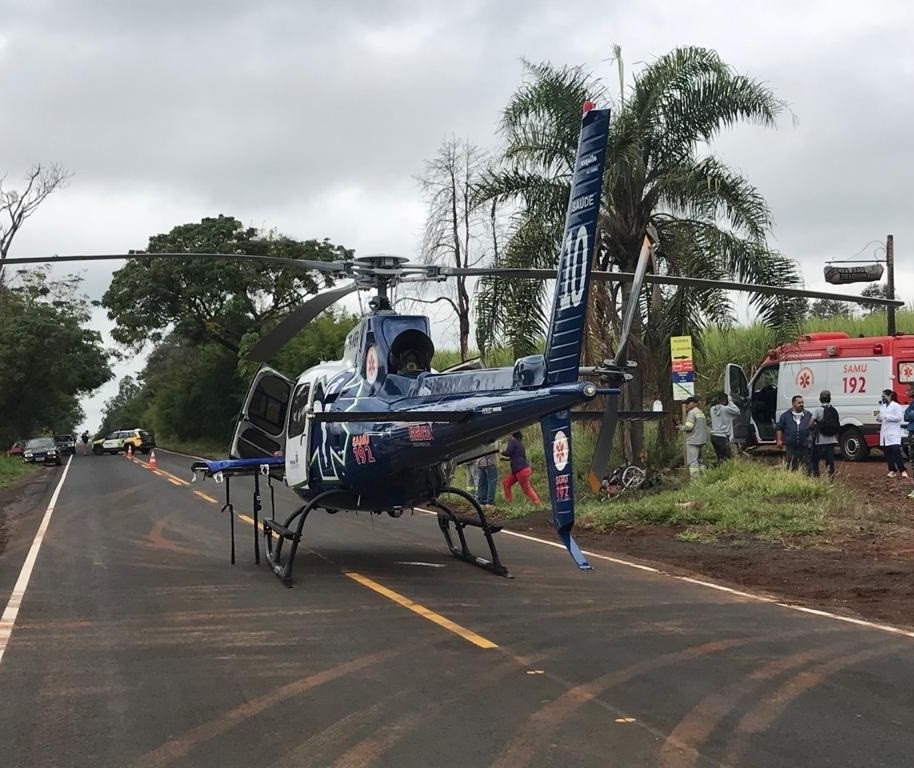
[235,312,596,511]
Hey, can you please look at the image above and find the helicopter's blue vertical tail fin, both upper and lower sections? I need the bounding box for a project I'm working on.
[540,105,609,570]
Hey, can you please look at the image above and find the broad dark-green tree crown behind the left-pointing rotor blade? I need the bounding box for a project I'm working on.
[102,215,351,354]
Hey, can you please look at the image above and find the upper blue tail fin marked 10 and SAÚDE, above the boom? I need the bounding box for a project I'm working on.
[545,103,609,384]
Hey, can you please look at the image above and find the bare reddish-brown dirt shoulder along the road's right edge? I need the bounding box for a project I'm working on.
[500,459,914,628]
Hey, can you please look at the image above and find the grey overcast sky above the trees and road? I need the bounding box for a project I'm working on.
[0,0,914,429]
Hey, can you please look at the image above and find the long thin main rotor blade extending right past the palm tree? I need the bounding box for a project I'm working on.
[441,267,904,307]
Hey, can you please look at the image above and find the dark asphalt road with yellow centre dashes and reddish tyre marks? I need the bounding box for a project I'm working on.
[0,451,914,768]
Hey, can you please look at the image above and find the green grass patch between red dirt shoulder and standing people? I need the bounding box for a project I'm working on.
[577,460,836,545]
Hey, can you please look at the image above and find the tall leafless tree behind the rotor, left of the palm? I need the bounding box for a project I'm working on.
[419,137,497,360]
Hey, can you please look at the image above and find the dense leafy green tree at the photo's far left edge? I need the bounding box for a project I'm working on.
[0,270,111,445]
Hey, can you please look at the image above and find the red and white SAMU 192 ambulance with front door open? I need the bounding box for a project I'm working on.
[724,331,914,461]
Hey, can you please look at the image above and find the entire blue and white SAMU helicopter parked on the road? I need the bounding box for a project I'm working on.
[6,102,902,585]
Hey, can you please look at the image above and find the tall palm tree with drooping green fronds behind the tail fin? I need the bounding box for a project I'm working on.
[477,47,798,451]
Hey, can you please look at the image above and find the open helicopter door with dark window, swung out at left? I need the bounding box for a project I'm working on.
[230,366,292,459]
